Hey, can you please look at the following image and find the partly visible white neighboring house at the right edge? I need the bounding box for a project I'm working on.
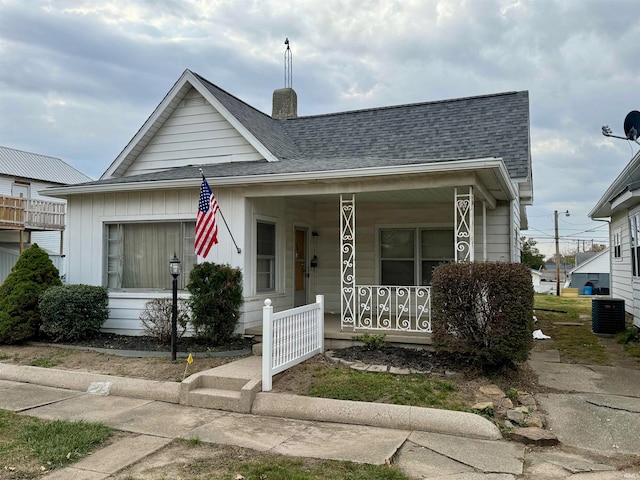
[589,152,640,327]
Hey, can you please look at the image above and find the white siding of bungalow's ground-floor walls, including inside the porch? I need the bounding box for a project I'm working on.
[68,188,512,334]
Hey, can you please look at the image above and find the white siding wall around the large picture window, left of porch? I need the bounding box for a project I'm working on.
[68,188,245,335]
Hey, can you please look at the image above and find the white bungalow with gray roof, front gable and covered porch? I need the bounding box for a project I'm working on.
[47,70,533,334]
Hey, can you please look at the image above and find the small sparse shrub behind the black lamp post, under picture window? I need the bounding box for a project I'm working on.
[140,298,189,344]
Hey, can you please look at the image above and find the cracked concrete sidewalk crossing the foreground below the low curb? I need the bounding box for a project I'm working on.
[0,372,524,479]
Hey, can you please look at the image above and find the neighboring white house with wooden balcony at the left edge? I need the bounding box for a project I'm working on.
[0,147,92,283]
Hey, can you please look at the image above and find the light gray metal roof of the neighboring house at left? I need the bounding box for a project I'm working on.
[0,147,91,185]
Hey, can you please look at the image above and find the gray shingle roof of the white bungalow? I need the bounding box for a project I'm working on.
[70,72,531,188]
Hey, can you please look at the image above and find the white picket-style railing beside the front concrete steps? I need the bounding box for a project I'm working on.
[262,295,324,392]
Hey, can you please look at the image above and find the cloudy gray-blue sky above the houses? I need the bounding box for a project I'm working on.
[0,0,640,255]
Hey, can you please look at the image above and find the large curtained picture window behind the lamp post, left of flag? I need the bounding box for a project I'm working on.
[106,222,196,290]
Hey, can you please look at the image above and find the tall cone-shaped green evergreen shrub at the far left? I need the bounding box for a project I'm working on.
[0,243,62,343]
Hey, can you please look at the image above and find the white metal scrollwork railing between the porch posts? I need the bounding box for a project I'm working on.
[354,285,431,333]
